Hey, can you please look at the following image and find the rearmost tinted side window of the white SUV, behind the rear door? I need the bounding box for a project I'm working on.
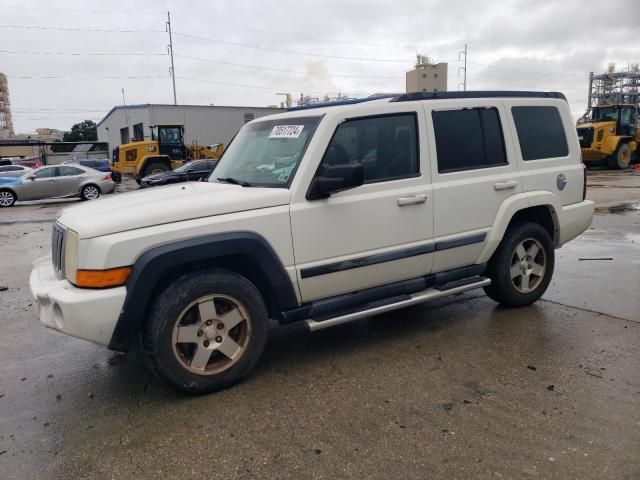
[511,107,569,160]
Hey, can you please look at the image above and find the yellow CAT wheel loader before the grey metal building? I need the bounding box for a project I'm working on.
[112,124,224,183]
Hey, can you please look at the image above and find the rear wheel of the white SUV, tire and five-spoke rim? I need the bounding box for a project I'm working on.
[484,222,555,307]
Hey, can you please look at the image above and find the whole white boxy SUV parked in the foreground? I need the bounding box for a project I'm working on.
[30,92,593,393]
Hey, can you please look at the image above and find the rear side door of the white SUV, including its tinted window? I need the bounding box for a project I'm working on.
[425,99,522,272]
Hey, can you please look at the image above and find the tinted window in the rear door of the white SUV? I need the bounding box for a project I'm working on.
[431,107,508,173]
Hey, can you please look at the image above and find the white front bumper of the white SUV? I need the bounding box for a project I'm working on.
[29,257,127,346]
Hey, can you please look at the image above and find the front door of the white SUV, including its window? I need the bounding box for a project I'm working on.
[291,104,433,301]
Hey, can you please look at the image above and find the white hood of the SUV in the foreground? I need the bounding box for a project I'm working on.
[58,182,289,238]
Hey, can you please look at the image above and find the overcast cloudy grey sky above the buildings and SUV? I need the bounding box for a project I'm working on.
[0,0,640,133]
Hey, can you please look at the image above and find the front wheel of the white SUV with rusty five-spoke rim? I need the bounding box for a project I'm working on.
[141,270,268,395]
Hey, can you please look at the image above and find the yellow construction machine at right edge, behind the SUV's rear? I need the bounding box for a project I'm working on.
[577,104,640,169]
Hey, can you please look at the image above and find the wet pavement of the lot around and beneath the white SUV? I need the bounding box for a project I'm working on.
[0,172,640,480]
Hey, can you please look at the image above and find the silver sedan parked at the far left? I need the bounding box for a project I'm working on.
[0,165,115,207]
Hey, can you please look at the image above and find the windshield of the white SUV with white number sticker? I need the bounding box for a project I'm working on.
[209,117,321,188]
